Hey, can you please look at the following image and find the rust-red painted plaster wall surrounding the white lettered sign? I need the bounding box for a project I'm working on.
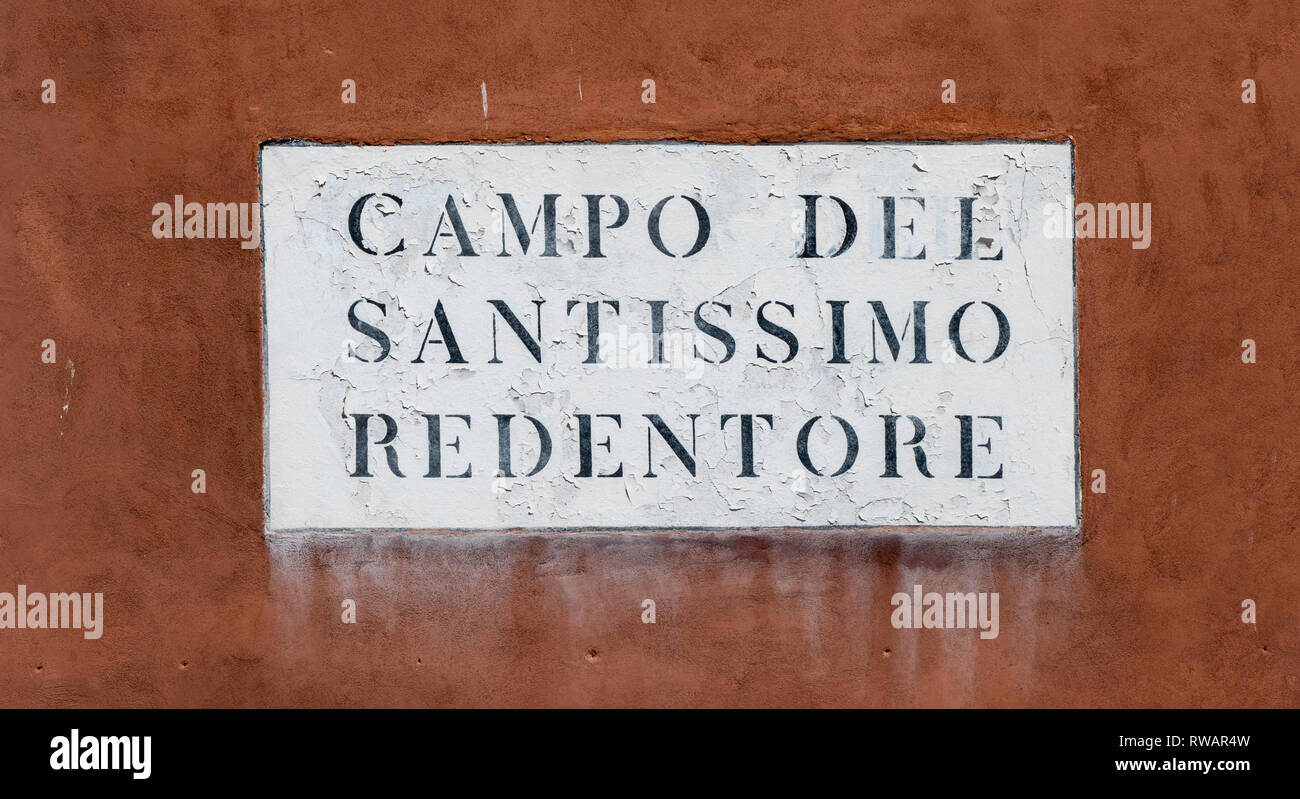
[0,0,1300,705]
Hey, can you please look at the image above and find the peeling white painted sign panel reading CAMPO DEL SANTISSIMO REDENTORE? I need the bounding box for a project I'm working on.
[261,142,1079,531]
